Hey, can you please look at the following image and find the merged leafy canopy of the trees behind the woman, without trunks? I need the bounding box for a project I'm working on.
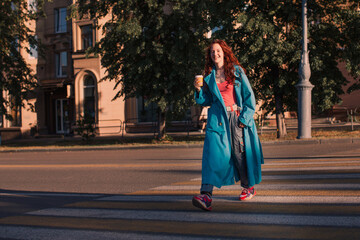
[74,0,360,137]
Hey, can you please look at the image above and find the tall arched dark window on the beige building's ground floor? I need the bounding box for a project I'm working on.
[84,75,96,121]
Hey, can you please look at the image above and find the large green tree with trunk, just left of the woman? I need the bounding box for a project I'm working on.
[73,0,208,138]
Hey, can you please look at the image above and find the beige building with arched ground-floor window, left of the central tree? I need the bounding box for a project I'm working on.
[2,0,125,140]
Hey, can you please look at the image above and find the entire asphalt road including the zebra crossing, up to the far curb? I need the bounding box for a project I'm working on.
[0,142,360,239]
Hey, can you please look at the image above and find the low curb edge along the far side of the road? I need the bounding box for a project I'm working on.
[0,138,360,153]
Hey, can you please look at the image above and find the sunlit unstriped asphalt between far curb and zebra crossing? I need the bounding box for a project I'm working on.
[0,143,360,194]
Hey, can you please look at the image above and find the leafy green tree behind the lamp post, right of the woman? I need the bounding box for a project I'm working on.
[210,0,360,137]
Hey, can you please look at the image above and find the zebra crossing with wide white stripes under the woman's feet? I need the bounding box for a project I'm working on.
[0,153,360,240]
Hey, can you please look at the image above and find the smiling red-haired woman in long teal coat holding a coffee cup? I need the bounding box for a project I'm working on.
[192,40,264,211]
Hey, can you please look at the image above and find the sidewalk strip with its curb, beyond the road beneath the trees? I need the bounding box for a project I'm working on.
[0,123,360,152]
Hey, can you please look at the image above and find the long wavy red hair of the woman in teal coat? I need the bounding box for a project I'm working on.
[204,39,245,84]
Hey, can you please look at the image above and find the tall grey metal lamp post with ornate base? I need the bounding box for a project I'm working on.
[296,0,314,139]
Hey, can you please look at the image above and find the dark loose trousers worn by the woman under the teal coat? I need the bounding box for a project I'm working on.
[200,111,249,194]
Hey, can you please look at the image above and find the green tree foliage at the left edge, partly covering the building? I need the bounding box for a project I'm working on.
[0,0,43,120]
